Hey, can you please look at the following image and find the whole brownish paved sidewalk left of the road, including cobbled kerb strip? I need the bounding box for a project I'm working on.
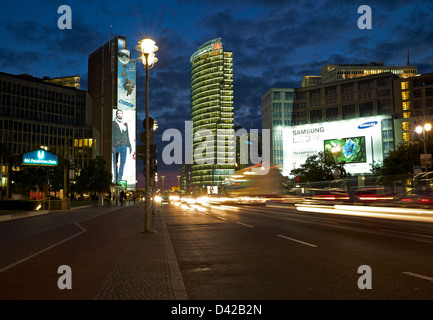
[0,203,188,300]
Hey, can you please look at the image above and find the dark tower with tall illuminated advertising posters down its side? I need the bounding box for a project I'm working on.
[88,36,137,189]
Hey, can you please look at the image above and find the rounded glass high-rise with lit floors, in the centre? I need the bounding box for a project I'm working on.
[190,38,236,190]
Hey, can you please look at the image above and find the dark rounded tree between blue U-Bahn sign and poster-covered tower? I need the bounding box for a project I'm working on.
[77,156,111,196]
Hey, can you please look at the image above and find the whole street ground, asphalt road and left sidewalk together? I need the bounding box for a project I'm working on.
[0,199,433,302]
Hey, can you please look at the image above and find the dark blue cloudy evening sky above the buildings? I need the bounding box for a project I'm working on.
[0,0,433,186]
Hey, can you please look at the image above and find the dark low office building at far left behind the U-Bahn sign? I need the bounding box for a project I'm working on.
[0,73,99,198]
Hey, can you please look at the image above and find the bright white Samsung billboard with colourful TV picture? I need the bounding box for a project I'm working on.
[282,116,391,176]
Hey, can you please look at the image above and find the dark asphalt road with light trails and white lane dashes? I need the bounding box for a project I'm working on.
[164,202,433,300]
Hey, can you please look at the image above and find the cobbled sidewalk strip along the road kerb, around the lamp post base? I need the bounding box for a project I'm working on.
[95,208,188,300]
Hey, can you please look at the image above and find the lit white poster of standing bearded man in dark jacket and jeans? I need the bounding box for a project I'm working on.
[112,109,136,188]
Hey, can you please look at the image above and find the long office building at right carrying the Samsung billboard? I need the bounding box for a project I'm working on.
[262,62,433,178]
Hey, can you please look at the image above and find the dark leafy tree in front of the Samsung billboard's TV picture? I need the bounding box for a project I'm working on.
[291,151,348,182]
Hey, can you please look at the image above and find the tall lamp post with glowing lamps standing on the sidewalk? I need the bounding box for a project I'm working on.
[135,38,158,232]
